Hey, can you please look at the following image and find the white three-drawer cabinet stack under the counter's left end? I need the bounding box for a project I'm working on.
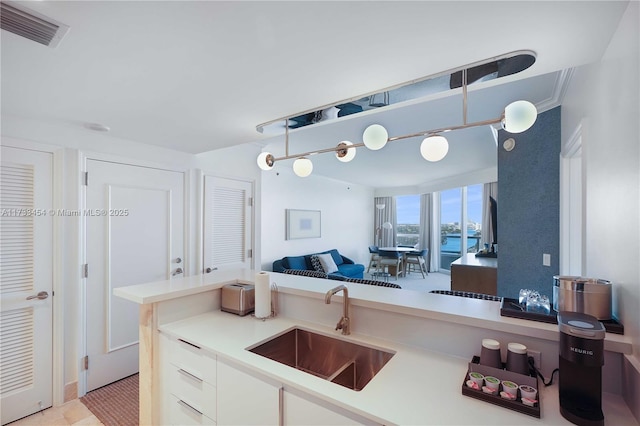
[160,334,217,425]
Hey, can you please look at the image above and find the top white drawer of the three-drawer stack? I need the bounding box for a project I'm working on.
[168,338,216,386]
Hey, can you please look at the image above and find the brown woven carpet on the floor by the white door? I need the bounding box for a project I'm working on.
[80,374,139,426]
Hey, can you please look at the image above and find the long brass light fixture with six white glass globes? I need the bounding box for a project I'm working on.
[257,56,538,177]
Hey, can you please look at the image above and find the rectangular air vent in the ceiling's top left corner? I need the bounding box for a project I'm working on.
[0,2,69,48]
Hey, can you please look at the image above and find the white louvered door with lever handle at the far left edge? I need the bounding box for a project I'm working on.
[0,147,55,424]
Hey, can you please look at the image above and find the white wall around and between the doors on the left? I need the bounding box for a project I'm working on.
[2,116,278,396]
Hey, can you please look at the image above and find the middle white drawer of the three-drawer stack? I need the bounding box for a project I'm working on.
[167,366,217,419]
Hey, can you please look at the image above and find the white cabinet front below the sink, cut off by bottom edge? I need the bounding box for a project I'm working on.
[283,391,371,426]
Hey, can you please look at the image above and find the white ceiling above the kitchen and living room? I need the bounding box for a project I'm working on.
[1,1,627,187]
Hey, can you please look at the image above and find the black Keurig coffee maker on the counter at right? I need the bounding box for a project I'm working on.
[558,311,605,426]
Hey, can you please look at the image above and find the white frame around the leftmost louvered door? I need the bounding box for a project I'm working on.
[2,136,65,407]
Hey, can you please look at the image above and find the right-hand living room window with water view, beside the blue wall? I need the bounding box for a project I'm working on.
[440,185,482,270]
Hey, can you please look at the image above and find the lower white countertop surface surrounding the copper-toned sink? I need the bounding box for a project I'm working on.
[160,311,637,425]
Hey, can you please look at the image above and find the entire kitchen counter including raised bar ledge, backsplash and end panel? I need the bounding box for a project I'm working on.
[114,269,637,425]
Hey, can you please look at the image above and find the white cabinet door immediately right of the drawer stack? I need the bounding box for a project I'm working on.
[217,360,280,426]
